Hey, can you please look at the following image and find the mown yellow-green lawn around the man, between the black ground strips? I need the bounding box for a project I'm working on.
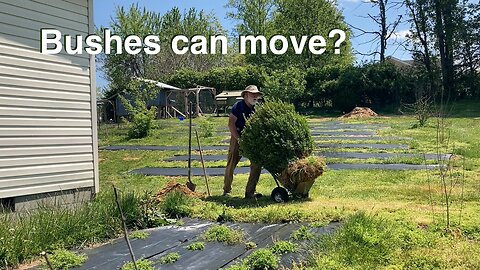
[94,103,480,269]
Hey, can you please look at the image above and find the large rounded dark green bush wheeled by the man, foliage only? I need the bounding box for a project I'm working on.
[240,100,314,174]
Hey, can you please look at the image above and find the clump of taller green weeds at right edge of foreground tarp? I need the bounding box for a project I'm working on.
[310,212,435,269]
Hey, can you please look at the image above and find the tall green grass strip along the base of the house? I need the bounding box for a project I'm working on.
[0,191,163,268]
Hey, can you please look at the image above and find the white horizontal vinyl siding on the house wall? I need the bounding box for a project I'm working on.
[0,0,98,198]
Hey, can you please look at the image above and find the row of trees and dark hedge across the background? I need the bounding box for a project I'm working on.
[98,0,480,111]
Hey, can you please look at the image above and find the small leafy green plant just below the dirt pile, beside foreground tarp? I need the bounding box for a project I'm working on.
[160,192,193,218]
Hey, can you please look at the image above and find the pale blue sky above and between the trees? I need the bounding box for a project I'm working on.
[93,0,411,87]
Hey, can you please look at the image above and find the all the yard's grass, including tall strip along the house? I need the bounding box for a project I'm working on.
[0,102,480,269]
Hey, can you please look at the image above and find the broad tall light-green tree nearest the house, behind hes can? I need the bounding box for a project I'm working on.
[100,5,225,97]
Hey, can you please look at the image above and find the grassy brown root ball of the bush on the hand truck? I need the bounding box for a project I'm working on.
[279,156,326,194]
